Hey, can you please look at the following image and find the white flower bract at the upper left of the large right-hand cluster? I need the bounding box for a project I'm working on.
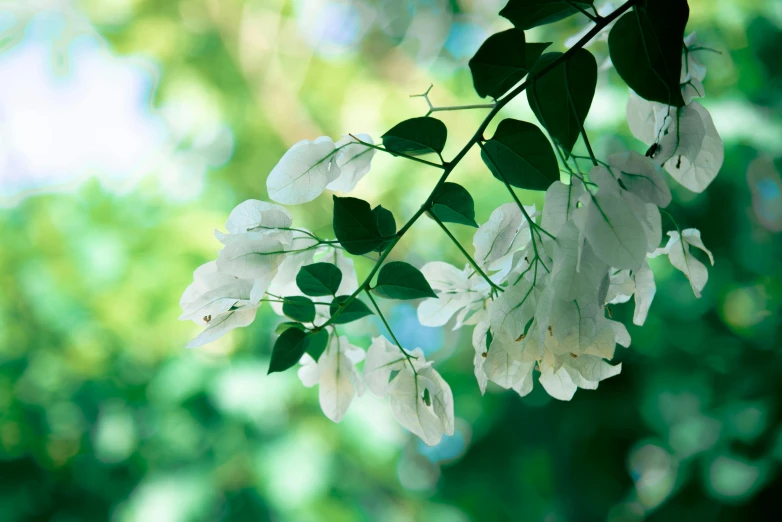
[472,203,537,277]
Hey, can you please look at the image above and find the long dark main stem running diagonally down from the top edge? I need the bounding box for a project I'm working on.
[318,0,638,329]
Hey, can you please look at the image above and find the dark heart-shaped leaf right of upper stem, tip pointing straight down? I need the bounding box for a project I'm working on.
[527,49,597,153]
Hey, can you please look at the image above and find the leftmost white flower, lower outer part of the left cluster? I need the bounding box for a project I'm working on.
[179,261,257,348]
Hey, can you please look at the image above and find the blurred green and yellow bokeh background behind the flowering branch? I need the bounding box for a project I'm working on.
[0,0,782,522]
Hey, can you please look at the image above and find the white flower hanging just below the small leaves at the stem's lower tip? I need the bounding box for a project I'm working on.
[298,335,365,422]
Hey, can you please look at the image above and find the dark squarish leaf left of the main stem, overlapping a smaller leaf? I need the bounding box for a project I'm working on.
[334,196,385,255]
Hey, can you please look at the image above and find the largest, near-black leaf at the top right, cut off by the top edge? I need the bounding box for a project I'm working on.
[608,0,690,107]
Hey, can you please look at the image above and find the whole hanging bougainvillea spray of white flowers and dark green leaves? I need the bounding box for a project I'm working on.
[181,0,723,445]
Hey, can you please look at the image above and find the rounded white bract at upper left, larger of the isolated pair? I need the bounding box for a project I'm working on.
[266,136,340,205]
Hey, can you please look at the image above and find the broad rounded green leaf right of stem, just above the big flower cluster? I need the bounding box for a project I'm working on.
[481,119,559,190]
